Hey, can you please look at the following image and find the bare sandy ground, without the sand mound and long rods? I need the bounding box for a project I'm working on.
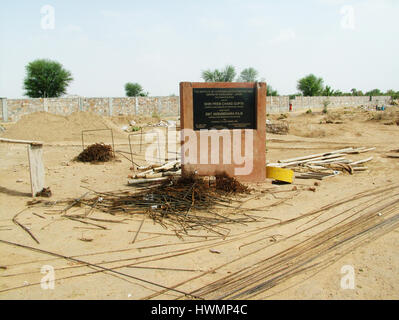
[0,110,399,299]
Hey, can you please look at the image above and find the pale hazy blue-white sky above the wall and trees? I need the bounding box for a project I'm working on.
[0,0,399,98]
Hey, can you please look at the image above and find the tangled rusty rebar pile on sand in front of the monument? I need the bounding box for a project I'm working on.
[65,175,256,236]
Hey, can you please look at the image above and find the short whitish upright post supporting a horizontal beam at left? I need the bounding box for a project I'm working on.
[28,145,45,197]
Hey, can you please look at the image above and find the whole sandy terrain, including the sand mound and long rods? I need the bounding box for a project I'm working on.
[0,107,399,300]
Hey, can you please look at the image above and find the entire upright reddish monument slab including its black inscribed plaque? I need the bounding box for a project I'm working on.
[180,82,266,182]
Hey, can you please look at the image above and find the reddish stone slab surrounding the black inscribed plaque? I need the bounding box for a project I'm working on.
[180,82,266,182]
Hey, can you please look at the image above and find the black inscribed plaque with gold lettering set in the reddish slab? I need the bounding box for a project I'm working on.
[193,88,256,131]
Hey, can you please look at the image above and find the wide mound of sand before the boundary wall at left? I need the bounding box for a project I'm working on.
[1,112,125,142]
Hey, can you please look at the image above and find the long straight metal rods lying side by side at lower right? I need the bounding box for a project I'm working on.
[190,186,399,300]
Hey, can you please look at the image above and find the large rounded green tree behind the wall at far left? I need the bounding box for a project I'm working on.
[24,59,73,98]
